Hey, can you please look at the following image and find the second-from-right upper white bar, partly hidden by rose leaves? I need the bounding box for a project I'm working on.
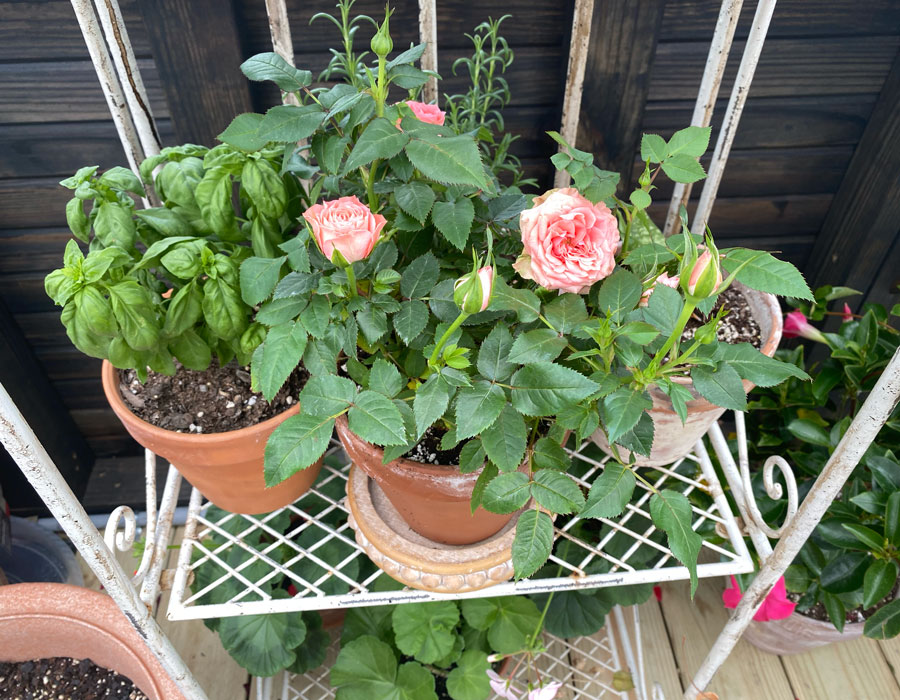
[663,0,744,236]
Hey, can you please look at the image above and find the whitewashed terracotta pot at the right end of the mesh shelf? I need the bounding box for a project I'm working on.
[591,283,782,467]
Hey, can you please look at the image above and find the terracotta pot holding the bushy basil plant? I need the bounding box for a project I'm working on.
[102,360,322,514]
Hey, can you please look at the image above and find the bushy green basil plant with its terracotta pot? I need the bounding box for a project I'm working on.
[46,144,317,513]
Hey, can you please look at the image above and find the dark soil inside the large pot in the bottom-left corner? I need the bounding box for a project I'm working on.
[0,657,147,700]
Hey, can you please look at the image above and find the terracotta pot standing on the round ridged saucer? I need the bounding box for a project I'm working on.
[335,416,514,545]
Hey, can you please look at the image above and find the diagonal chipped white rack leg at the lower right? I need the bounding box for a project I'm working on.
[684,349,900,700]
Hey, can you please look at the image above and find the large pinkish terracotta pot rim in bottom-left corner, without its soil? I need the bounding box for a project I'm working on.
[0,583,184,700]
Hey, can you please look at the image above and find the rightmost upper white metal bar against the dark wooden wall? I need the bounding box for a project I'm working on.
[691,0,776,234]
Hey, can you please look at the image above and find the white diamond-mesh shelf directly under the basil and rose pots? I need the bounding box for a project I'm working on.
[167,430,753,620]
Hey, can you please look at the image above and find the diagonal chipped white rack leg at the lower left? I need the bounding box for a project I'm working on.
[0,384,208,700]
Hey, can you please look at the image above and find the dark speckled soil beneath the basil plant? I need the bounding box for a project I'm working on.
[119,358,308,433]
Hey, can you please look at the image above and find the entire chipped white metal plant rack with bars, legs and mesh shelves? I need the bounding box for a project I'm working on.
[0,0,900,700]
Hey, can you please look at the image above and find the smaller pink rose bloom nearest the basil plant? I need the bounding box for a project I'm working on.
[303,195,387,263]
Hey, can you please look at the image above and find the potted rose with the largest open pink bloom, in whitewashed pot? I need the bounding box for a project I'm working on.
[516,127,811,474]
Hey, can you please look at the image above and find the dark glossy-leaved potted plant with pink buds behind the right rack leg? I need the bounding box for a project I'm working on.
[746,286,900,654]
